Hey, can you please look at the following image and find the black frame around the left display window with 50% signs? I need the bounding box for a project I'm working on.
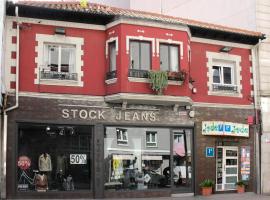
[14,120,95,198]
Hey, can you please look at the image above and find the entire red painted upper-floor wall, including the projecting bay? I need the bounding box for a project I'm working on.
[17,21,254,105]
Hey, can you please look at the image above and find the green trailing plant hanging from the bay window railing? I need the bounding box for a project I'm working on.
[148,71,168,95]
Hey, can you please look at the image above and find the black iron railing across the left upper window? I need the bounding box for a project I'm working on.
[40,71,78,81]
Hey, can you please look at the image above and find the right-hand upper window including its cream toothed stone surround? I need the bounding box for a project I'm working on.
[207,52,242,97]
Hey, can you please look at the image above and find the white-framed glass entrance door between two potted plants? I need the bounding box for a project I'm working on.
[216,146,238,191]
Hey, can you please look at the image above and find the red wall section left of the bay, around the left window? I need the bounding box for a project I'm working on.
[20,24,105,95]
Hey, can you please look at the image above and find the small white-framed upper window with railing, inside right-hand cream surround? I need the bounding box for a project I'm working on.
[212,63,237,92]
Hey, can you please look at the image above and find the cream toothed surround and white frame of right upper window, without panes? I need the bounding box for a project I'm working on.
[206,52,243,98]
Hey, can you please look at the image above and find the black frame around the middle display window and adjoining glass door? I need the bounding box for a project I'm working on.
[102,123,196,198]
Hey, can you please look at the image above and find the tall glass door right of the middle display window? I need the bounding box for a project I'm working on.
[171,130,193,193]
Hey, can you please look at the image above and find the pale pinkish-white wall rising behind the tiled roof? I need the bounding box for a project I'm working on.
[91,0,256,30]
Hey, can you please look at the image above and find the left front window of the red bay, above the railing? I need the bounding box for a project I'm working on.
[129,40,151,78]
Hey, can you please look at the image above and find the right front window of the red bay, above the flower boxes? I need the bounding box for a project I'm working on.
[159,44,179,72]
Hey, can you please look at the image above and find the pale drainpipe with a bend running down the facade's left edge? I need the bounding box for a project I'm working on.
[1,6,20,199]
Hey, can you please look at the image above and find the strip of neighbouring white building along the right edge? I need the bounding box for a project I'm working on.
[256,0,270,194]
